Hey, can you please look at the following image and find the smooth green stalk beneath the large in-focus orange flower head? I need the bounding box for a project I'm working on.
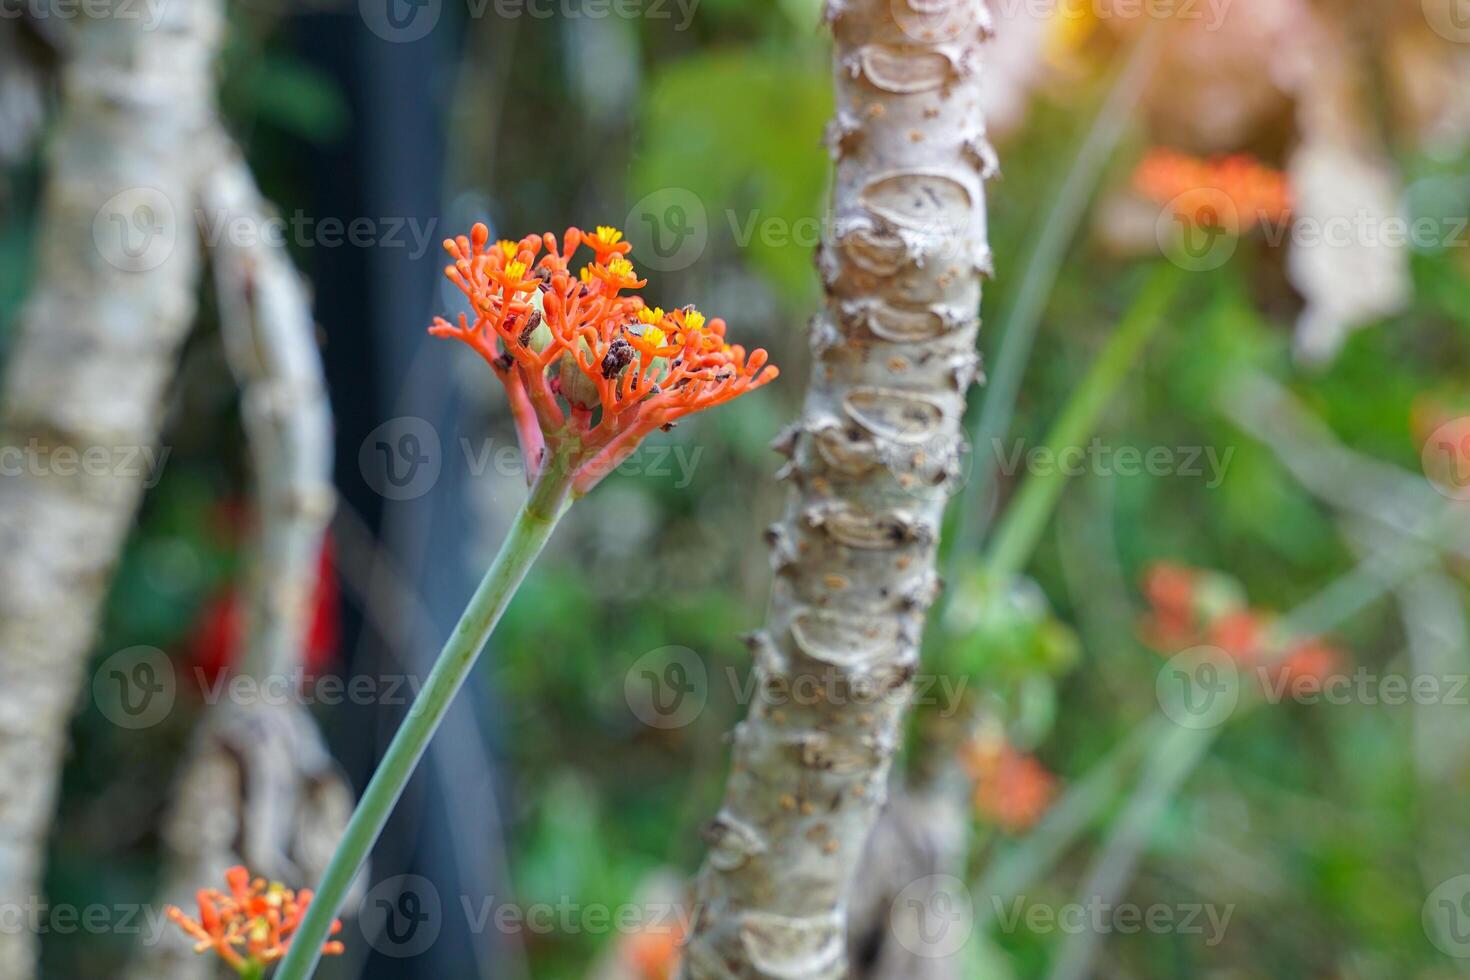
[276,460,570,980]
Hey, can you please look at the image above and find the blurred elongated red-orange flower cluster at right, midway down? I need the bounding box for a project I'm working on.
[1139,561,1344,695]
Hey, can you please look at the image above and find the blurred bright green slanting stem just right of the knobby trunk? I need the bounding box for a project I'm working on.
[978,262,1183,580]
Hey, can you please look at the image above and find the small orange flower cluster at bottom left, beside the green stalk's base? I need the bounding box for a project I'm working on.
[165,867,343,977]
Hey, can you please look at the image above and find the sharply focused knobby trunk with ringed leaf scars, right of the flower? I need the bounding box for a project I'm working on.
[684,0,994,980]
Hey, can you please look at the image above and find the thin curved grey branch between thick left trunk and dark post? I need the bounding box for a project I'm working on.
[128,132,353,980]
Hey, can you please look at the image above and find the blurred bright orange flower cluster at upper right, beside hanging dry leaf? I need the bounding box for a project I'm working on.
[1133,148,1292,234]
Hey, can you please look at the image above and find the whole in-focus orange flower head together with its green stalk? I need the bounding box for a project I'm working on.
[276,225,778,980]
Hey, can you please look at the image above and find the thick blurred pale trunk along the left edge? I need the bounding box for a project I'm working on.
[0,3,221,980]
